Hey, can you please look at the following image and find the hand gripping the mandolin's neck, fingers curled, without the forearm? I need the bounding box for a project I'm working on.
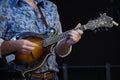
[66,23,83,45]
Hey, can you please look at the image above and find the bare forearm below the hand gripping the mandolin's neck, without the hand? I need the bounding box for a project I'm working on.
[55,40,72,57]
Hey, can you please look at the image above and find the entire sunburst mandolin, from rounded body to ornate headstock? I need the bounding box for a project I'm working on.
[7,13,118,76]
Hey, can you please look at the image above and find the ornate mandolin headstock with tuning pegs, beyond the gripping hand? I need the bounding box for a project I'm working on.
[85,13,118,30]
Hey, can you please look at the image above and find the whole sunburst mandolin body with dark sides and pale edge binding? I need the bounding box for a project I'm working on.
[11,32,55,76]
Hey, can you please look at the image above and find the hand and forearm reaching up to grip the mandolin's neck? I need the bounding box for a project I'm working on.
[55,24,83,56]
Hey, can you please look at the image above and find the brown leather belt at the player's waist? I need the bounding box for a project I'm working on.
[32,72,55,80]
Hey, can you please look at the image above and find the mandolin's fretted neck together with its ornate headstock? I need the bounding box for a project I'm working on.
[43,13,118,47]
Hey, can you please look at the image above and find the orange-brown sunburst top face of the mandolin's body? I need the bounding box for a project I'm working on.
[15,37,49,65]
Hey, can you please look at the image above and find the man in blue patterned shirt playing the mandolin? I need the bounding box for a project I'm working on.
[0,0,83,80]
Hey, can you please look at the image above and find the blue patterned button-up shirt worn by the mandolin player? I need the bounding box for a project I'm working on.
[0,0,62,73]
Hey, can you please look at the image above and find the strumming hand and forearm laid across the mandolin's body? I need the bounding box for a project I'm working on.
[1,39,38,55]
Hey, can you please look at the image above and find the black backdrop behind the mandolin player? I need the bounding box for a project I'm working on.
[52,0,120,80]
